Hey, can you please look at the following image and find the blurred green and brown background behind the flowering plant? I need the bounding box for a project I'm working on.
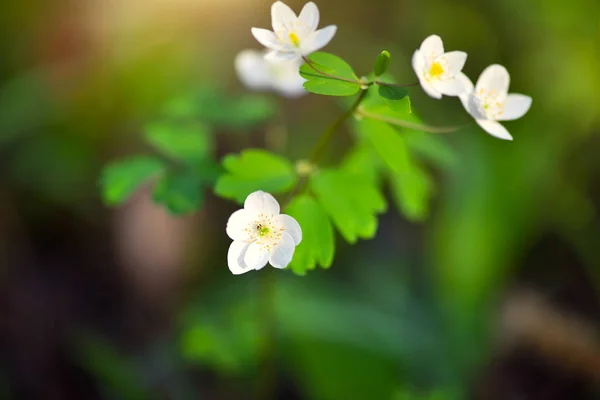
[0,0,600,400]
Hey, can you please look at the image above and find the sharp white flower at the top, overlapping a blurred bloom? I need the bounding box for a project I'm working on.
[252,1,337,61]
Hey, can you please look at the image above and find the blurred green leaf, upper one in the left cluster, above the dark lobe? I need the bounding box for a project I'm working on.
[145,121,213,164]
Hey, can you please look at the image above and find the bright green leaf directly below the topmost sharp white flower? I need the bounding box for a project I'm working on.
[300,52,361,96]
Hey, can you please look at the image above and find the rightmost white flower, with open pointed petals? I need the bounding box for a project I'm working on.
[460,64,531,140]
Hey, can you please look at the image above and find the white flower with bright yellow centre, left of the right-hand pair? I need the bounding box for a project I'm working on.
[412,35,467,99]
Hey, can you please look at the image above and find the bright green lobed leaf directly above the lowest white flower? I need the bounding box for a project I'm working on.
[215,149,298,203]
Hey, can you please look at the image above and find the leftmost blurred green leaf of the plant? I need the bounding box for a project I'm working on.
[100,156,165,206]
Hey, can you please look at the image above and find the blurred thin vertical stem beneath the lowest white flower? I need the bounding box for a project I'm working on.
[256,268,277,400]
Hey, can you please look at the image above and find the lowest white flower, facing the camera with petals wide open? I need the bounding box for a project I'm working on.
[227,190,302,275]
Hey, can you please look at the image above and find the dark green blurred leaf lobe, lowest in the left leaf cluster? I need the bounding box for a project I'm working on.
[153,171,204,215]
